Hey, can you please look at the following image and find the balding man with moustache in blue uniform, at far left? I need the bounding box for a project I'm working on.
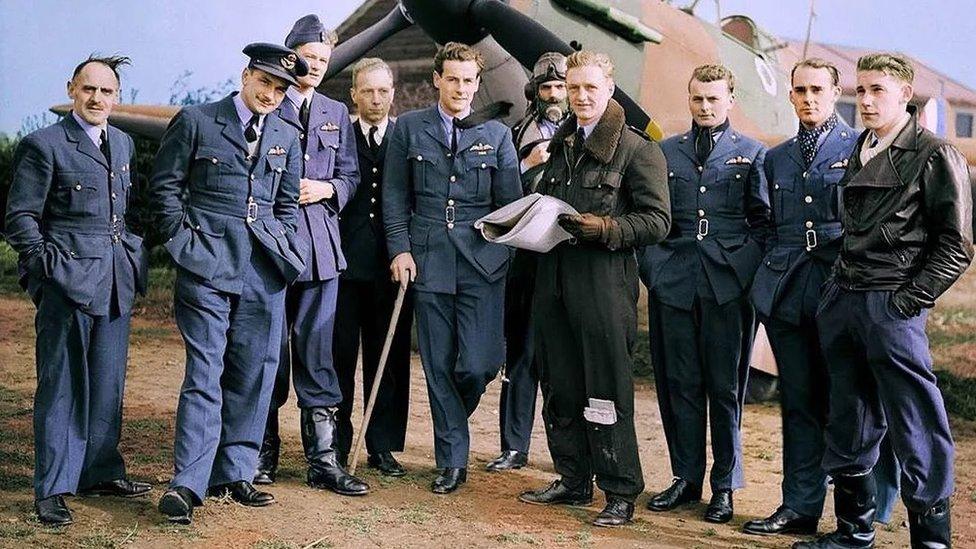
[6,56,150,526]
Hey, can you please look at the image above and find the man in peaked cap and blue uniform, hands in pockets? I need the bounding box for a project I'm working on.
[150,44,308,524]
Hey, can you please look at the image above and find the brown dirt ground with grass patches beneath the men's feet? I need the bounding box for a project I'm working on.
[0,288,976,549]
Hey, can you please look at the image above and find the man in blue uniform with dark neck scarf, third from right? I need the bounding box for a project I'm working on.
[641,65,769,523]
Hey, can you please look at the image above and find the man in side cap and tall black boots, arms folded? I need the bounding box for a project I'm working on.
[255,15,369,496]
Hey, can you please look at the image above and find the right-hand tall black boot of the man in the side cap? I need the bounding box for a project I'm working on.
[302,408,369,496]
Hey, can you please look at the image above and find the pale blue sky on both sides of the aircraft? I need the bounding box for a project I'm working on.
[0,0,976,134]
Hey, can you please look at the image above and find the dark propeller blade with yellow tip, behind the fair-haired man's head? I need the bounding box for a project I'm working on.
[468,0,652,130]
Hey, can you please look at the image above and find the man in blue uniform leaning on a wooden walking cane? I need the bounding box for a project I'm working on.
[383,42,522,494]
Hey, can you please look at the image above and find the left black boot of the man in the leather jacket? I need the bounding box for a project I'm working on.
[793,472,877,549]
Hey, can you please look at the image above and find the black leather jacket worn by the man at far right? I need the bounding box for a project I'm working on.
[834,107,973,317]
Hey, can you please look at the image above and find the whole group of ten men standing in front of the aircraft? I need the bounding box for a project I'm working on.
[6,9,973,548]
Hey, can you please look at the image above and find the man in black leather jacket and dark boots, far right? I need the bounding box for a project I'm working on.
[794,54,973,548]
